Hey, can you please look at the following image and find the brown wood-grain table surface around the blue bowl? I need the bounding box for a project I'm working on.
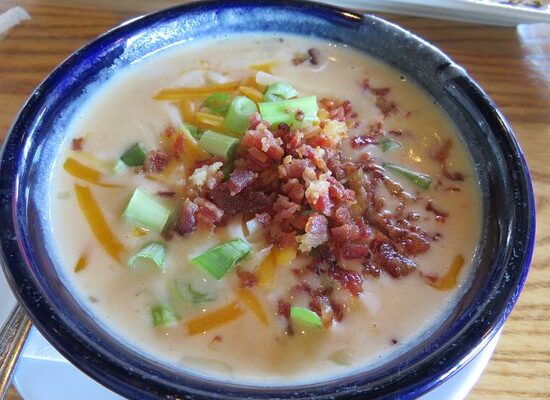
[0,0,550,400]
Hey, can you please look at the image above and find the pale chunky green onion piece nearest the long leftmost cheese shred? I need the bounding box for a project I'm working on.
[123,189,171,233]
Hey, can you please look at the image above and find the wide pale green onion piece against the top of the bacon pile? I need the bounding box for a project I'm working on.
[259,96,319,126]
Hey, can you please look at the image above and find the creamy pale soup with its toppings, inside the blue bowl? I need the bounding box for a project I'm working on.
[51,36,480,385]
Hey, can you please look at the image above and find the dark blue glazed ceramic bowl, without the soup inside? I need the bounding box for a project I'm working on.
[0,0,535,399]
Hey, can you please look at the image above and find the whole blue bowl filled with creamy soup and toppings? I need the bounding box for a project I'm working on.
[0,1,534,399]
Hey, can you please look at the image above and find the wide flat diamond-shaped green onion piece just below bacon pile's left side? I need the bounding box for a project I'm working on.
[191,239,252,279]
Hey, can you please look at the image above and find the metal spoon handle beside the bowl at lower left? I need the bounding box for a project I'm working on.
[0,304,31,399]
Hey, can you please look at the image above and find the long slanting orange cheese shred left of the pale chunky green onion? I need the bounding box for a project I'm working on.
[75,184,125,262]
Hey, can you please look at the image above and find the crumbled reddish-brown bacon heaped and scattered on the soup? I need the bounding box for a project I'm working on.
[143,94,461,328]
